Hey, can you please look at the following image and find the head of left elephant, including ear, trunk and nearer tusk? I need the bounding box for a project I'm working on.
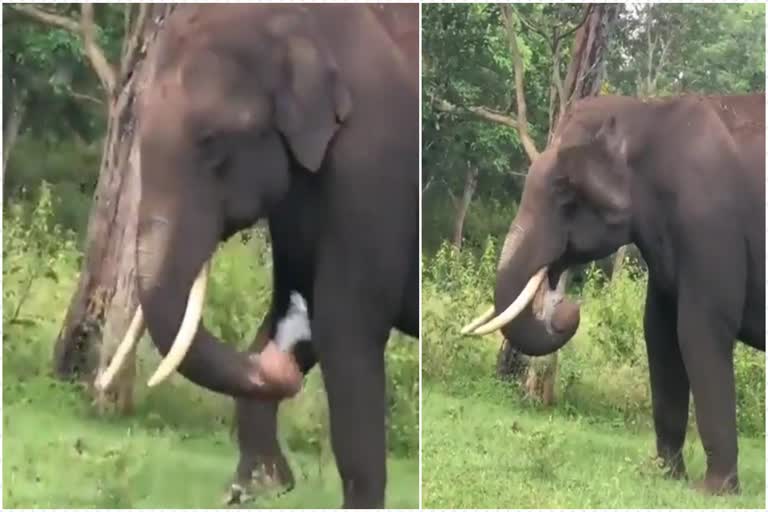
[136,16,352,396]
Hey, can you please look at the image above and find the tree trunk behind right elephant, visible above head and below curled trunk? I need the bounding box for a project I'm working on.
[496,4,617,405]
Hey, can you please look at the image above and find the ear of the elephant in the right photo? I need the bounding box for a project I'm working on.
[557,116,630,222]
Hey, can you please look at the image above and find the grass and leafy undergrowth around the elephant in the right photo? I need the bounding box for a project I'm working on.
[422,244,766,509]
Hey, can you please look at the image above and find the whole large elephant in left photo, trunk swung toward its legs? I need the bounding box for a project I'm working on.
[104,4,420,508]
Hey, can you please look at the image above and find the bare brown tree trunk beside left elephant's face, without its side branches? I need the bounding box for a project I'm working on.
[53,4,171,412]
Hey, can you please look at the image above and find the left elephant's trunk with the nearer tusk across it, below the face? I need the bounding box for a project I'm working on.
[136,207,298,398]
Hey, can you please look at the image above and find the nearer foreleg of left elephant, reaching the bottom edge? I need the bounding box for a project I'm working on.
[312,273,391,508]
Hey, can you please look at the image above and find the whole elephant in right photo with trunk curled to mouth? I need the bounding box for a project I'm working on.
[464,94,765,493]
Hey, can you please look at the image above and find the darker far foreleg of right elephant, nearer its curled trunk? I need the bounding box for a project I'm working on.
[644,280,690,478]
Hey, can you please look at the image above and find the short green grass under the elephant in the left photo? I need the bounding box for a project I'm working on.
[3,377,418,508]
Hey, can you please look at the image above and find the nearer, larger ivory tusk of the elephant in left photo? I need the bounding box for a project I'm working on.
[147,262,209,387]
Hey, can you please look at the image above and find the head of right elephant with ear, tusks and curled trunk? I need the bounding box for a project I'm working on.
[463,112,631,356]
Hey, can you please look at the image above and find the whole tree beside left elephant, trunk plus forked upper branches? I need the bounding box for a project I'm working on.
[13,4,172,411]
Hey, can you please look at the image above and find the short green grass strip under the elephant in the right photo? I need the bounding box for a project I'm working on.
[422,378,765,509]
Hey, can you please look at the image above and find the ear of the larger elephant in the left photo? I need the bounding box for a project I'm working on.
[275,37,352,172]
